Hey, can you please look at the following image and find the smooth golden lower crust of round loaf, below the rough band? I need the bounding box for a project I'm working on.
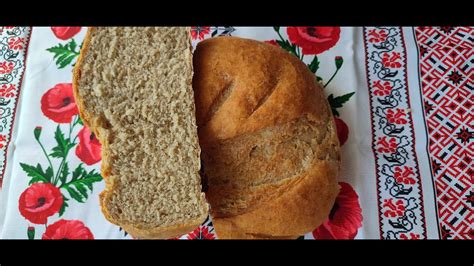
[211,162,339,238]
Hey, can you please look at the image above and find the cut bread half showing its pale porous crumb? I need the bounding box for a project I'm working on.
[73,27,208,238]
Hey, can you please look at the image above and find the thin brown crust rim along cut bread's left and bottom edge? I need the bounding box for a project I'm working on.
[72,27,207,238]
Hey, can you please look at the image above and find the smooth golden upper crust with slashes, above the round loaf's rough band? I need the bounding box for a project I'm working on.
[193,37,328,142]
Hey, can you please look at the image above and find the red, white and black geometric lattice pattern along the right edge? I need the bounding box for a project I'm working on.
[415,27,474,239]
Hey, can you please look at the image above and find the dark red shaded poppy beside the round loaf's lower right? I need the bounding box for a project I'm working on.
[313,182,362,239]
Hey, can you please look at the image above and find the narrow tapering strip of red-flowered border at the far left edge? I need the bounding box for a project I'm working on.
[0,27,30,187]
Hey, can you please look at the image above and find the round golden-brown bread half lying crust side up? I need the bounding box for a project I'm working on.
[193,37,340,238]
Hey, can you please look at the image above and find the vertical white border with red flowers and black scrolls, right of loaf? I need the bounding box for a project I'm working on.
[364,27,426,239]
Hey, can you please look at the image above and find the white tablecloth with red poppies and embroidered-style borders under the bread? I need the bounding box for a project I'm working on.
[0,26,474,239]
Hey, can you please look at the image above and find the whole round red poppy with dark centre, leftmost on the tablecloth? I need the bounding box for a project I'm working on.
[19,183,63,224]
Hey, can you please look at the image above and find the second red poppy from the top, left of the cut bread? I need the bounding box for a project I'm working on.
[41,83,79,123]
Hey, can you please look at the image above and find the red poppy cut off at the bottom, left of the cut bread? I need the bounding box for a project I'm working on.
[42,219,94,239]
